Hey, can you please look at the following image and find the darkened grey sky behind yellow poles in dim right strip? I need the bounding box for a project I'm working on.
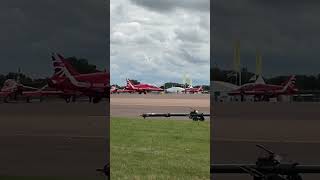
[212,0,320,76]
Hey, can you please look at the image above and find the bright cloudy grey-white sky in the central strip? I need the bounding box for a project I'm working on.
[110,0,210,85]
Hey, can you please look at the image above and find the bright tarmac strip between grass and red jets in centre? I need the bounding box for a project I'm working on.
[110,94,210,120]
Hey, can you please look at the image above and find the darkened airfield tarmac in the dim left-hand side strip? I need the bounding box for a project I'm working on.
[0,101,109,179]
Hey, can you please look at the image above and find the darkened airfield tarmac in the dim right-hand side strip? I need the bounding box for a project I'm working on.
[211,103,320,180]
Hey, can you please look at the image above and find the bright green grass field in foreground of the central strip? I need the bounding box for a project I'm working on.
[110,117,210,180]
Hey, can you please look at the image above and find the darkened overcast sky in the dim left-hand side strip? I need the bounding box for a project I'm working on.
[0,0,109,77]
